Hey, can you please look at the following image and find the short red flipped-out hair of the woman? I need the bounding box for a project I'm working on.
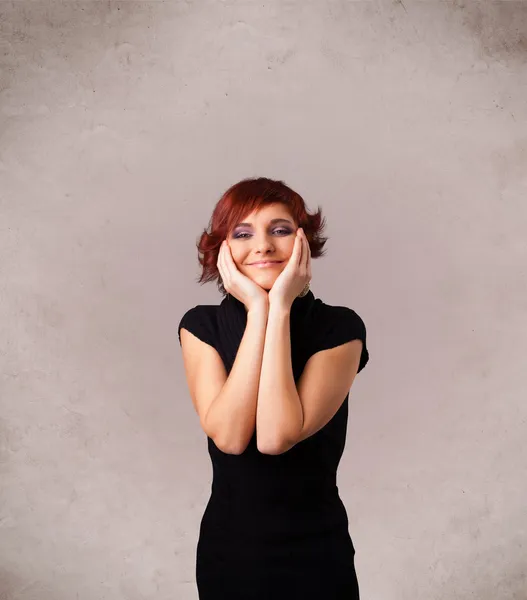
[197,177,328,295]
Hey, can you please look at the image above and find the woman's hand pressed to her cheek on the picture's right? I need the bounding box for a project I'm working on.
[269,227,311,309]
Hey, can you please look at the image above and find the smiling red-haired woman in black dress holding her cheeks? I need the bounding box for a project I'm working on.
[178,178,369,600]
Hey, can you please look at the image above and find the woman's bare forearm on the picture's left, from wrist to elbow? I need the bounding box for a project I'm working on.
[205,307,268,454]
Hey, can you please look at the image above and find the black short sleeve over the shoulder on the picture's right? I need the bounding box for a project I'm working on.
[313,306,370,373]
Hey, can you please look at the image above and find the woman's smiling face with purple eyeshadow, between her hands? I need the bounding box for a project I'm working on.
[228,203,298,290]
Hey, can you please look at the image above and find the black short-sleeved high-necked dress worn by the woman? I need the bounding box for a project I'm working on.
[178,291,369,600]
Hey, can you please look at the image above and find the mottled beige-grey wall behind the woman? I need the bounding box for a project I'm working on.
[0,0,527,600]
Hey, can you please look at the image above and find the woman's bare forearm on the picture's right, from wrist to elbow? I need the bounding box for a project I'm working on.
[256,305,303,454]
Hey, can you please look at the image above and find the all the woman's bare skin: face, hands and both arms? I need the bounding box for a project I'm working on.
[181,204,362,454]
